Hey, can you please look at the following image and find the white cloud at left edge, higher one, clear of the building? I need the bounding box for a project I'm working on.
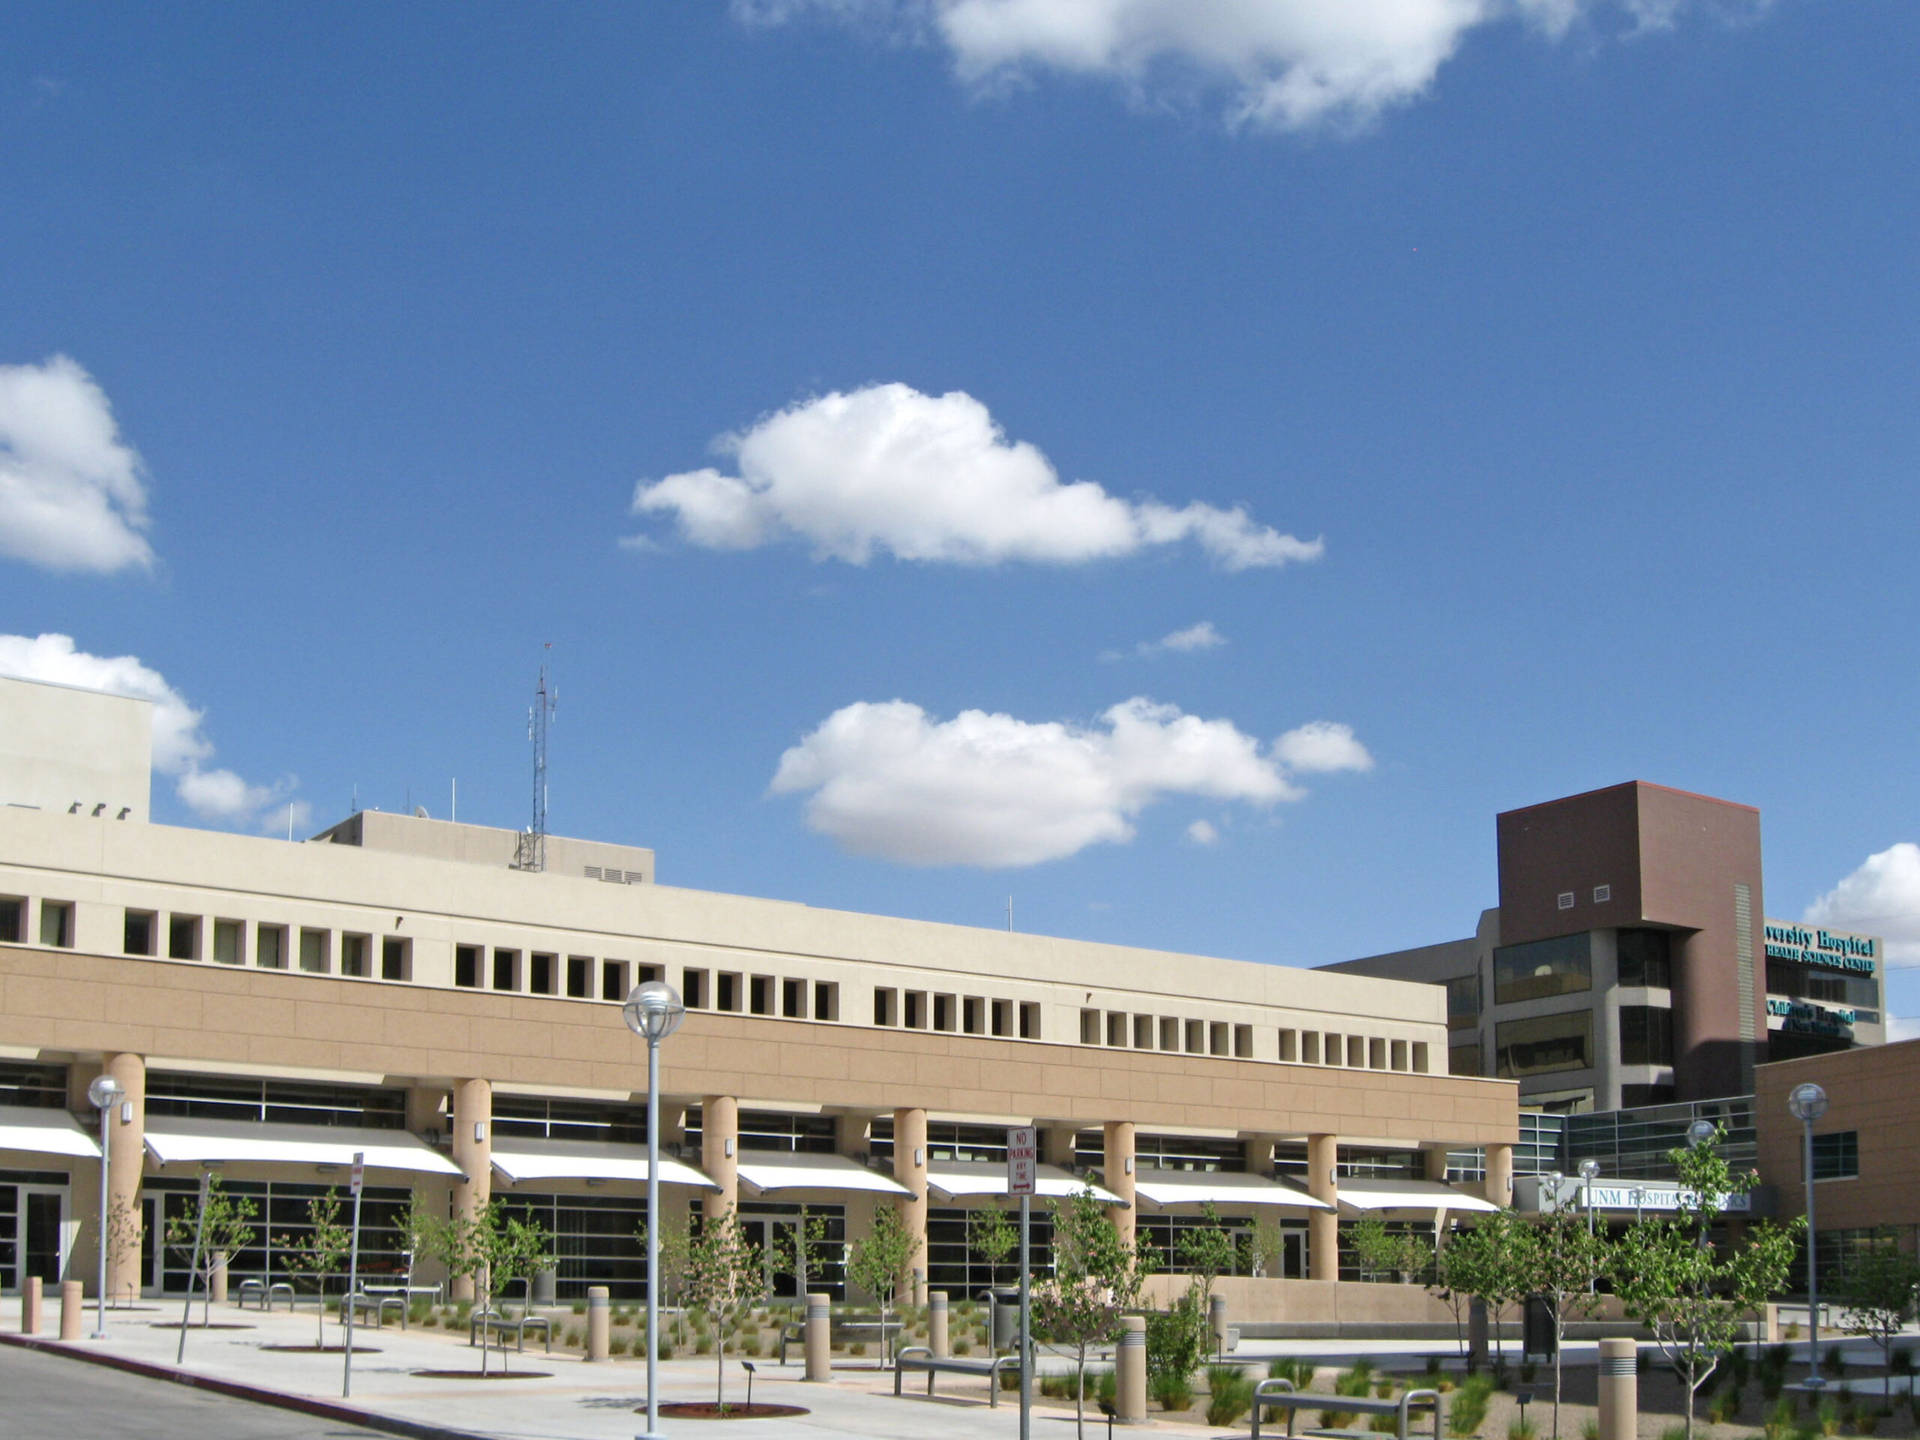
[0,355,154,574]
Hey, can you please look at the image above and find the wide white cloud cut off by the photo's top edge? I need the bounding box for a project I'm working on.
[733,0,1768,131]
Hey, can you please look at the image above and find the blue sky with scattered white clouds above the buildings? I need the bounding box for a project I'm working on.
[0,0,1920,1014]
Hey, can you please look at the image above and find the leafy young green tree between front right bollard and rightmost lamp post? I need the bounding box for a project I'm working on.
[1613,1129,1807,1440]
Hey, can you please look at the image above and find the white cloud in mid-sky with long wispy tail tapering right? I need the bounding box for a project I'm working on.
[632,384,1325,570]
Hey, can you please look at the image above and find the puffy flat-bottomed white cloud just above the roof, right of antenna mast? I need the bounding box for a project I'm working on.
[770,697,1367,868]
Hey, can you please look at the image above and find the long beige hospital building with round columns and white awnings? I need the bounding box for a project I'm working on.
[0,680,1519,1317]
